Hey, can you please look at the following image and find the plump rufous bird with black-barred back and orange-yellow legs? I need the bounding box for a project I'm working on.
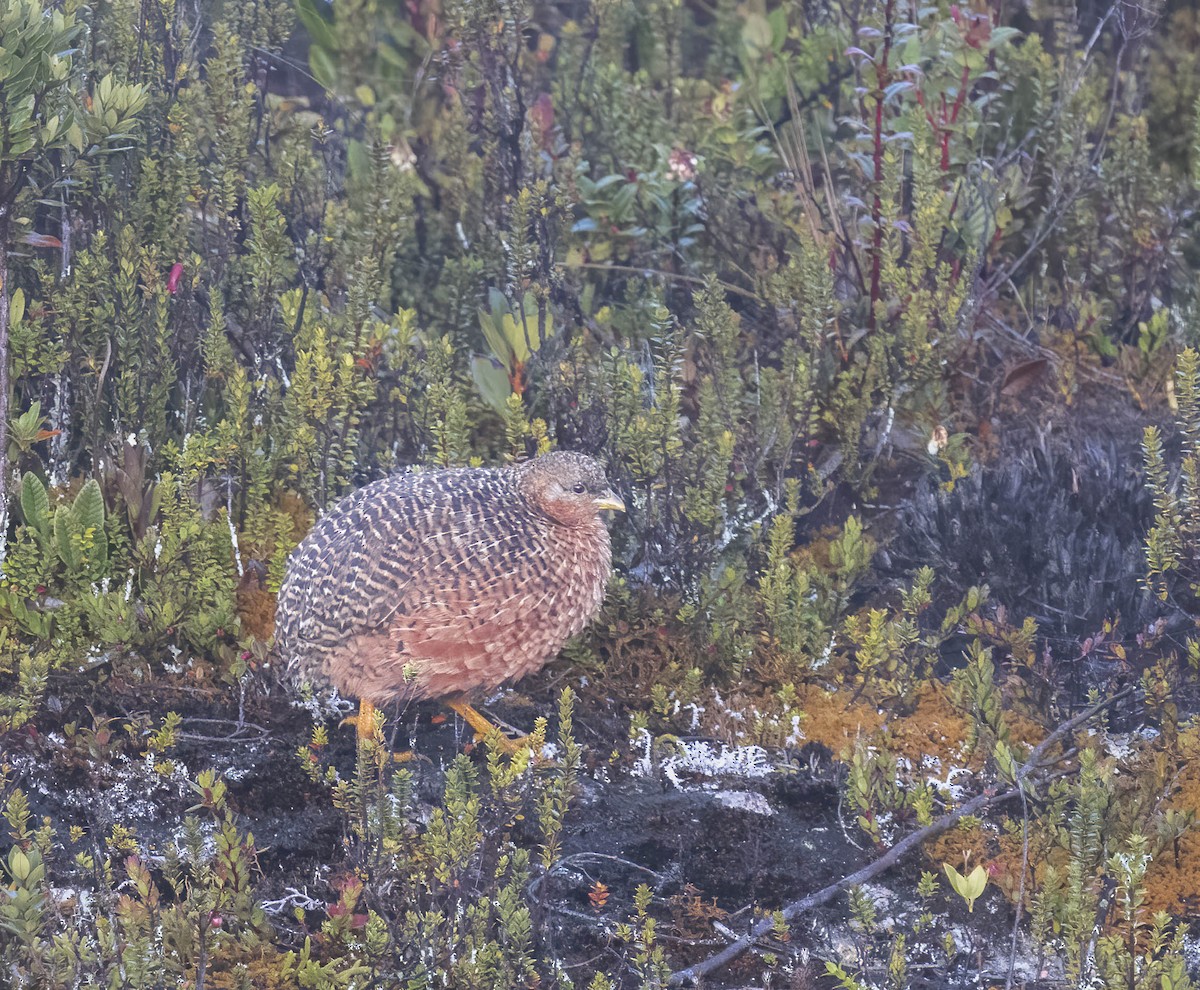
[275,451,625,751]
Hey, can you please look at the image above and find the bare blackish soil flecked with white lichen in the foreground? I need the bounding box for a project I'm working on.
[5,657,1032,988]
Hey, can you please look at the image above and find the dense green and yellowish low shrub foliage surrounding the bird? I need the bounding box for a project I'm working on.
[0,0,1200,988]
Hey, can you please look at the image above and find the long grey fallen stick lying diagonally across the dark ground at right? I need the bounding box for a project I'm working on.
[668,686,1134,986]
